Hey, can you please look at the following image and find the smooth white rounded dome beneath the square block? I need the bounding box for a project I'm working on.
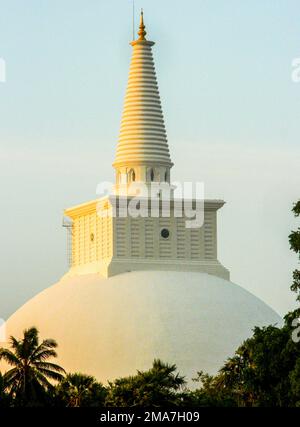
[2,271,281,382]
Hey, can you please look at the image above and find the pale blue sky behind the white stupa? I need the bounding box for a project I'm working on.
[0,0,300,317]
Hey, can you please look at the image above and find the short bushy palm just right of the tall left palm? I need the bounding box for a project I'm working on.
[57,373,106,407]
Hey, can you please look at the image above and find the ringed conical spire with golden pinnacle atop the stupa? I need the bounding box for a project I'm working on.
[113,12,172,181]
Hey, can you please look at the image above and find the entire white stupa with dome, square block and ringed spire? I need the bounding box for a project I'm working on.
[1,15,281,382]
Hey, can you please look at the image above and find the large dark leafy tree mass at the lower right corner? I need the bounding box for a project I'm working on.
[190,324,300,407]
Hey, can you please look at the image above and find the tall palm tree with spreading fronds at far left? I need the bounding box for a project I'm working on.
[0,327,65,405]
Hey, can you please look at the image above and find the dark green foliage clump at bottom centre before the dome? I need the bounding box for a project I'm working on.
[106,360,185,407]
